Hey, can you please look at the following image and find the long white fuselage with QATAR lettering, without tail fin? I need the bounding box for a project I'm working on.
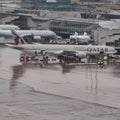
[11,44,116,54]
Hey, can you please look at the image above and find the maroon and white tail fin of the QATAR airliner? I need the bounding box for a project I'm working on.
[11,30,27,45]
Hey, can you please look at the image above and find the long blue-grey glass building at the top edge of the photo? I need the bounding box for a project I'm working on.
[21,0,94,12]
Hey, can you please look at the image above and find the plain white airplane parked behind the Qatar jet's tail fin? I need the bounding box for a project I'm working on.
[0,29,56,44]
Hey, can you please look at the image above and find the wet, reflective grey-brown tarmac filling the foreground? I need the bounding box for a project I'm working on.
[0,46,120,120]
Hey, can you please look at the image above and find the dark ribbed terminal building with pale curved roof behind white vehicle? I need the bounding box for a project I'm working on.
[49,17,98,38]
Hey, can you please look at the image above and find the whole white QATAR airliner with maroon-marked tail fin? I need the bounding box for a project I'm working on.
[6,30,116,60]
